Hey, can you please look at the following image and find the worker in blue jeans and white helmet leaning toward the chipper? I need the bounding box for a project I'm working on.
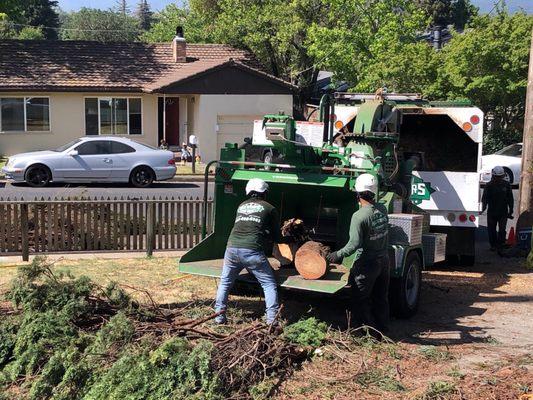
[215,178,285,324]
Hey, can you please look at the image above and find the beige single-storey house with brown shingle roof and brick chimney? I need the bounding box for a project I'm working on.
[0,36,294,160]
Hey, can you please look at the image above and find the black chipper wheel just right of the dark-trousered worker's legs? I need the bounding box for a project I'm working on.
[390,251,422,318]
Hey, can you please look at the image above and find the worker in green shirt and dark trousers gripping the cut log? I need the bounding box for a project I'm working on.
[327,174,390,333]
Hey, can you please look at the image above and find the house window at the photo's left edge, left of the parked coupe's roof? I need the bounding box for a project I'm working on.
[0,97,50,132]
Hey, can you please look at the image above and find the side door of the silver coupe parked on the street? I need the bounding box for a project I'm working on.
[62,140,113,180]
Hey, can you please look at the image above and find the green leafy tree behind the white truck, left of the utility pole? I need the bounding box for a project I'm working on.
[438,9,533,152]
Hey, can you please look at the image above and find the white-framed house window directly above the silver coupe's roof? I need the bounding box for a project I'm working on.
[85,97,142,135]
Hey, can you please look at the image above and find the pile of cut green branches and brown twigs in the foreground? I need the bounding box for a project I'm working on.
[0,259,309,400]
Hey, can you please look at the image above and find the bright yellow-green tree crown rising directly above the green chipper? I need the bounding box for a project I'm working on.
[308,0,433,91]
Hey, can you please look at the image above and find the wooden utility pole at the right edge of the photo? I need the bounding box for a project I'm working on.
[517,28,533,229]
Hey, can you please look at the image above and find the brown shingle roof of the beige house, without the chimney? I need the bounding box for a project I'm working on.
[0,40,292,92]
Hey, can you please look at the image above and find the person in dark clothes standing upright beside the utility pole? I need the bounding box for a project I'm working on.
[481,166,514,251]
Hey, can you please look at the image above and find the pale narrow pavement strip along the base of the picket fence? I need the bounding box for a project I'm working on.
[0,250,186,268]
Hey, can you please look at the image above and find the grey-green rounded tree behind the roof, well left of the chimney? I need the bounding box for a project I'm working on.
[61,7,141,42]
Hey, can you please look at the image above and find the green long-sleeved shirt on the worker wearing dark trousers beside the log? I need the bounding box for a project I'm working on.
[337,204,389,259]
